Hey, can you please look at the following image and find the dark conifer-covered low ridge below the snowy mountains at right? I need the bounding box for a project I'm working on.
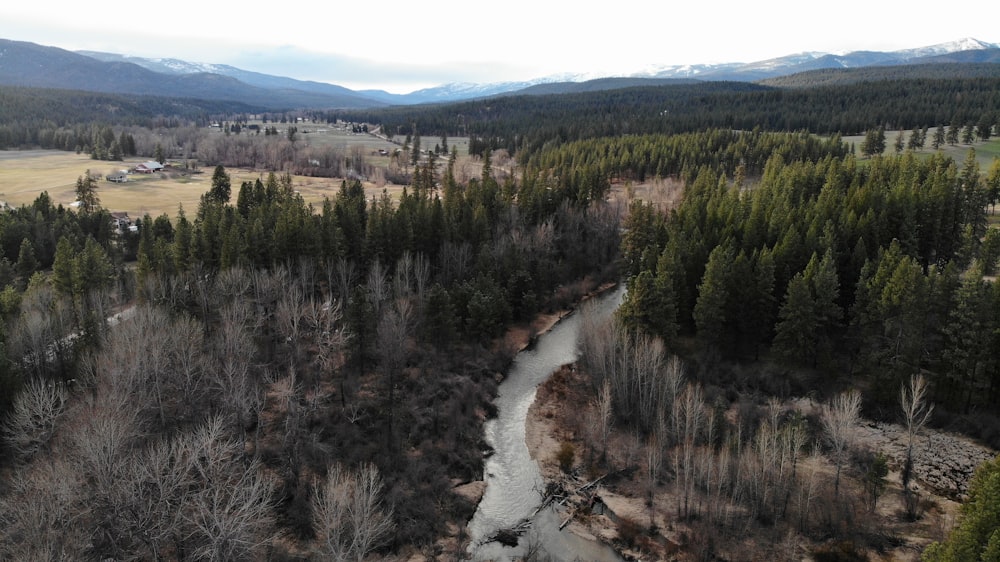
[339,76,1000,158]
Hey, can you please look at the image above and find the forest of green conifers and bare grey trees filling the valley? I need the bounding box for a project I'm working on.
[0,64,1000,560]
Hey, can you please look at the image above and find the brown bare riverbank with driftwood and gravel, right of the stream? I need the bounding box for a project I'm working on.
[525,365,996,561]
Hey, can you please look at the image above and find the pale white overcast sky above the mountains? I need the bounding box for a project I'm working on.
[0,0,1000,93]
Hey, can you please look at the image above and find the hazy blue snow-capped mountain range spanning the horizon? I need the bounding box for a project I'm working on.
[0,39,1000,110]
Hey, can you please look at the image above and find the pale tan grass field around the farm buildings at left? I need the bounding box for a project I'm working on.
[0,150,402,218]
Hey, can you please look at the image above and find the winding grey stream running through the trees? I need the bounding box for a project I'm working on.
[468,286,625,561]
